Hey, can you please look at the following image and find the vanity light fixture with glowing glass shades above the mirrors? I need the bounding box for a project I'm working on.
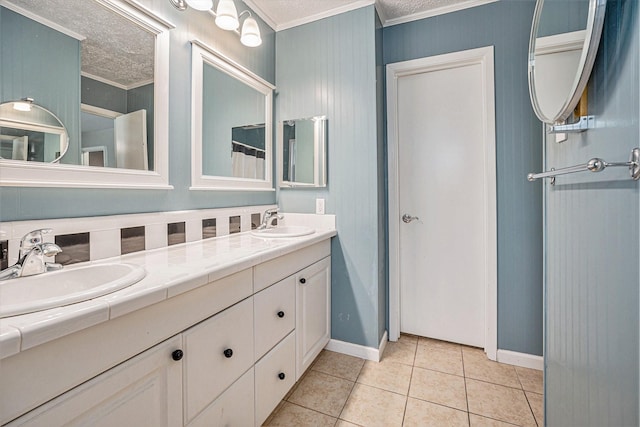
[169,0,262,47]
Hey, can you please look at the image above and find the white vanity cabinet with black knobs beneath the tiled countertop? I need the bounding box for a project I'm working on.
[5,239,331,427]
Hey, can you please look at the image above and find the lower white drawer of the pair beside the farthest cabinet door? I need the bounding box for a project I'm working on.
[256,331,296,425]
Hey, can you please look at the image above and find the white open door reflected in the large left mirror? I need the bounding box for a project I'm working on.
[114,110,149,170]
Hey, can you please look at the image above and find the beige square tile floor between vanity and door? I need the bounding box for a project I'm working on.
[264,335,544,427]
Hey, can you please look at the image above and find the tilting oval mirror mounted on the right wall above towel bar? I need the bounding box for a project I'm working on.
[529,0,606,124]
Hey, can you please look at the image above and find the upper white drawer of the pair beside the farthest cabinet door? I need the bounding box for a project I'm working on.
[253,277,296,360]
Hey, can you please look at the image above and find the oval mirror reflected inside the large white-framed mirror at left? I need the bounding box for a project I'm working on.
[0,99,69,163]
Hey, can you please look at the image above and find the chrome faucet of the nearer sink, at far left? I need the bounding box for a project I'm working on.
[0,228,62,280]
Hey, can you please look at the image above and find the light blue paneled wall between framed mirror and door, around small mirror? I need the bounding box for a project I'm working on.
[276,6,386,348]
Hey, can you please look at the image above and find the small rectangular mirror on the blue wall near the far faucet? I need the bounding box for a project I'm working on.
[278,116,327,187]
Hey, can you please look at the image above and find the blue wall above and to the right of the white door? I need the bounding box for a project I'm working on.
[383,1,542,355]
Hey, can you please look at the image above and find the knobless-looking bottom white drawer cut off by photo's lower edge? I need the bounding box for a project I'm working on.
[189,368,255,427]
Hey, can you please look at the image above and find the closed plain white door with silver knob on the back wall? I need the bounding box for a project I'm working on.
[390,48,496,354]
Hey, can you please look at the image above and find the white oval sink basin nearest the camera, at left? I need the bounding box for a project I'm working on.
[0,264,147,318]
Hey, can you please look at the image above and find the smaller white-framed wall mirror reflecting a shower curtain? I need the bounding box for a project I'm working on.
[191,40,275,191]
